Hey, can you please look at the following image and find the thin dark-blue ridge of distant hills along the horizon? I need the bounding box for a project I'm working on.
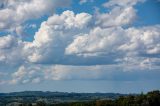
[0,91,127,98]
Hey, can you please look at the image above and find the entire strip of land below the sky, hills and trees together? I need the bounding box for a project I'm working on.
[0,90,160,106]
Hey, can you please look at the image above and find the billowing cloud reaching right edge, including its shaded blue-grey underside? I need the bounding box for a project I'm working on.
[65,25,160,68]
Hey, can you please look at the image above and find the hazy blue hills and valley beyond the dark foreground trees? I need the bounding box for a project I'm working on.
[0,91,126,104]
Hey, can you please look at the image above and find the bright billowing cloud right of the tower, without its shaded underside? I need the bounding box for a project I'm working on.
[66,25,160,57]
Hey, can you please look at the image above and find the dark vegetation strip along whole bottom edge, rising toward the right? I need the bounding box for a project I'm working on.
[1,90,160,106]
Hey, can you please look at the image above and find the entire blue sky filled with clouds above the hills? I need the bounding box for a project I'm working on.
[0,0,160,93]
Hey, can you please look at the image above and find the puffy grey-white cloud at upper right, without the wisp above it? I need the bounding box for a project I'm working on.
[96,7,136,27]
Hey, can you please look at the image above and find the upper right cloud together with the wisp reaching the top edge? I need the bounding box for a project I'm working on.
[95,0,145,27]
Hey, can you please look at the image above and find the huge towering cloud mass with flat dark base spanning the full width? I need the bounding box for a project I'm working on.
[0,8,160,65]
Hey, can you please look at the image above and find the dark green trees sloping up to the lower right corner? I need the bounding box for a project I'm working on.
[50,91,160,106]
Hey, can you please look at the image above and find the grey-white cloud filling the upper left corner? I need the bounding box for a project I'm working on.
[0,0,70,30]
